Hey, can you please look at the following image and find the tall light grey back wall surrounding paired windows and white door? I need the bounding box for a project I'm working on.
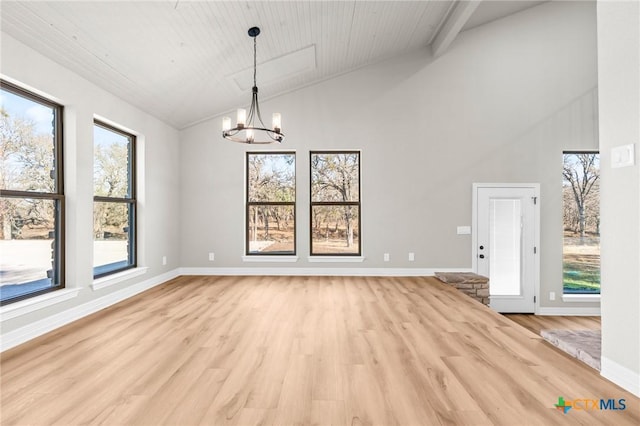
[181,2,598,306]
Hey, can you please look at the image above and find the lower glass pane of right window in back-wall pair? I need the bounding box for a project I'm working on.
[311,205,360,254]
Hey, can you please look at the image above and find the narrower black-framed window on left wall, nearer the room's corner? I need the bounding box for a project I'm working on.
[93,121,136,278]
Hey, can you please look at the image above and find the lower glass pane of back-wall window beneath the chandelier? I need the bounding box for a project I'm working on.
[247,204,296,254]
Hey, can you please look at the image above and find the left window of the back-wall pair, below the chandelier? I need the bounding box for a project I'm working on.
[246,152,296,255]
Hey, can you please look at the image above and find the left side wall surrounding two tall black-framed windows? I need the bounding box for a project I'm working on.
[0,33,180,336]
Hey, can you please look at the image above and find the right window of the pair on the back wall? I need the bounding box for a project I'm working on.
[310,151,361,256]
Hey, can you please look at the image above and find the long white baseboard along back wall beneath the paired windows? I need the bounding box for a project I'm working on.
[179,267,472,277]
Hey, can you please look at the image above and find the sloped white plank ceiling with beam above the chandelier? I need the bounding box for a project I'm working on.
[0,0,543,129]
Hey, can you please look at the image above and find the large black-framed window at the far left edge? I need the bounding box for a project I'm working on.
[0,81,64,305]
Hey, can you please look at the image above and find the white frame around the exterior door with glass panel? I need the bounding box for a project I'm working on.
[471,183,540,315]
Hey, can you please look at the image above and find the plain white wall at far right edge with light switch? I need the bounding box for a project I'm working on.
[598,2,640,396]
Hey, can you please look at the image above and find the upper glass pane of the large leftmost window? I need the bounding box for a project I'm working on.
[0,89,56,192]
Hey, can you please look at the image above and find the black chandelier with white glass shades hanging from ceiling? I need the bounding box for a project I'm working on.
[222,27,284,144]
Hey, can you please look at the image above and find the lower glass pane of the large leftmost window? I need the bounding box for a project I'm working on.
[0,197,59,301]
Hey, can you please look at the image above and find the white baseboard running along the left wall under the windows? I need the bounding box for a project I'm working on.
[0,269,179,352]
